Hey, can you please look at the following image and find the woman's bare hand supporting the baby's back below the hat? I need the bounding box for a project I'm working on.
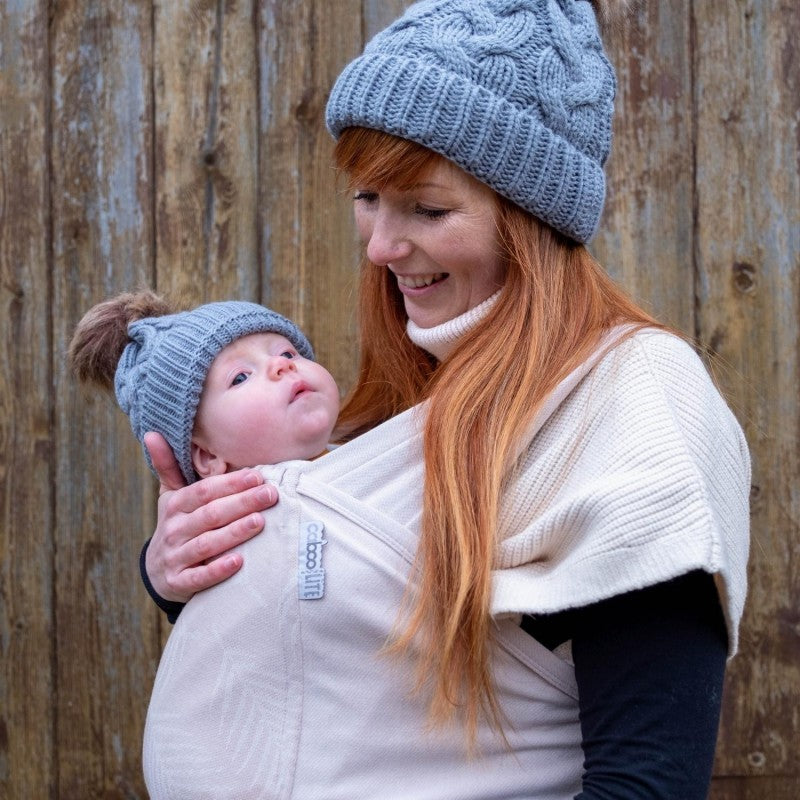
[144,433,278,603]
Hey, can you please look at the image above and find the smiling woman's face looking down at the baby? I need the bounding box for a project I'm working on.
[355,159,504,328]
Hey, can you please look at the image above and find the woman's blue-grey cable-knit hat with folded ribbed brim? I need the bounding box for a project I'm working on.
[326,0,616,242]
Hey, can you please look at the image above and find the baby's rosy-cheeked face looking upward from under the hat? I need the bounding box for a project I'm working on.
[192,333,339,474]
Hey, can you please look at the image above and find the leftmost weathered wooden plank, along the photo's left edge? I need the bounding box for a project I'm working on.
[0,2,55,797]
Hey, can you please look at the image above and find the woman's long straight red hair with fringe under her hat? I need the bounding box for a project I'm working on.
[335,128,661,741]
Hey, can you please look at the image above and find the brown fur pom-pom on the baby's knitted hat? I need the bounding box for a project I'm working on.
[68,290,173,390]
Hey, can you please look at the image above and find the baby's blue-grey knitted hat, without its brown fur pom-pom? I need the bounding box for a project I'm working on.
[114,301,314,483]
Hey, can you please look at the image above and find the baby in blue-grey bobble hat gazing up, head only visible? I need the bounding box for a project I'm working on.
[69,291,339,483]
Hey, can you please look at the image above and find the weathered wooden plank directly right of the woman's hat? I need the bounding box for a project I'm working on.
[592,0,695,335]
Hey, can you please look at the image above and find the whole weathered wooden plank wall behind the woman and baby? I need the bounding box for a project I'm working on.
[0,0,800,800]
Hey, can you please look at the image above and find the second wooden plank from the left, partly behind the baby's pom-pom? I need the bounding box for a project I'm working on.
[51,2,158,798]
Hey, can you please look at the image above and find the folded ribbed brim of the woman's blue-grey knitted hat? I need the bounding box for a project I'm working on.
[326,54,605,243]
